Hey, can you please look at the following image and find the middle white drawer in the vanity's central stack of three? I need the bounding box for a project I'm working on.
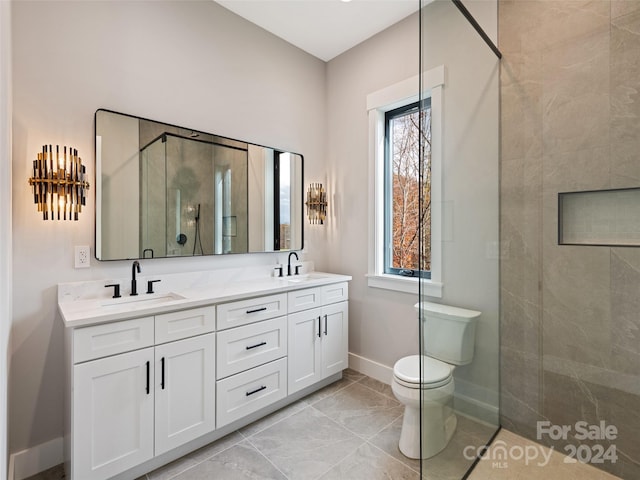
[216,317,287,378]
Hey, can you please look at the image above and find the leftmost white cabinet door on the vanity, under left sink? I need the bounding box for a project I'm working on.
[72,348,154,480]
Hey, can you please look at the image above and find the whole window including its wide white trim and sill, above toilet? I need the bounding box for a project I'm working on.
[367,65,446,297]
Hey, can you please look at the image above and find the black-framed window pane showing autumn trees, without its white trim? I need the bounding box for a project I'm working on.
[384,98,431,278]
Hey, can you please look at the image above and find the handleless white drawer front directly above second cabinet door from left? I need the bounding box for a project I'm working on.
[156,306,216,343]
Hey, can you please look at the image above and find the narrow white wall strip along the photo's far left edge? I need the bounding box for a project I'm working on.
[0,2,11,478]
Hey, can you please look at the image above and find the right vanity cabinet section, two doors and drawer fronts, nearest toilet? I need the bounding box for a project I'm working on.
[288,282,349,394]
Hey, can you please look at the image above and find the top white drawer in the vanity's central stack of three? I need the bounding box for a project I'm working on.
[217,293,287,330]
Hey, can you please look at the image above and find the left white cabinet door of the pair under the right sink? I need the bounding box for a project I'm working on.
[288,308,322,395]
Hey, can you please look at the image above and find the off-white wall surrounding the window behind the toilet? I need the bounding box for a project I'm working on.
[327,1,499,418]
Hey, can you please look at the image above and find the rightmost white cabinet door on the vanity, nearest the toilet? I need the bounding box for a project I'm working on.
[322,302,349,378]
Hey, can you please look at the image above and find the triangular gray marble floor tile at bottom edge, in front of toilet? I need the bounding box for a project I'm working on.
[320,443,420,480]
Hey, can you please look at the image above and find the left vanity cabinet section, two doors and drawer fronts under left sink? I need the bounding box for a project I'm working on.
[69,307,215,480]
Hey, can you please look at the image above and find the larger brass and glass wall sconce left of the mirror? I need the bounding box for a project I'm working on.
[29,145,89,220]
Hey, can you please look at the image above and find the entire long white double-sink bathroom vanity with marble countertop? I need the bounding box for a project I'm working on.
[58,272,351,480]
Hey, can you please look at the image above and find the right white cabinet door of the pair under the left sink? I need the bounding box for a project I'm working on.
[155,333,216,455]
